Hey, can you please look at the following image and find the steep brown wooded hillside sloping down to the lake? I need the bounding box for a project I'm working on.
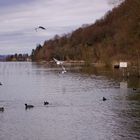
[32,0,140,64]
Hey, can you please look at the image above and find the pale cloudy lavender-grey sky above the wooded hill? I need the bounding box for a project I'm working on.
[0,0,112,55]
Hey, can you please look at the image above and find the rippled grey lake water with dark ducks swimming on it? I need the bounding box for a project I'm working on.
[0,62,140,140]
